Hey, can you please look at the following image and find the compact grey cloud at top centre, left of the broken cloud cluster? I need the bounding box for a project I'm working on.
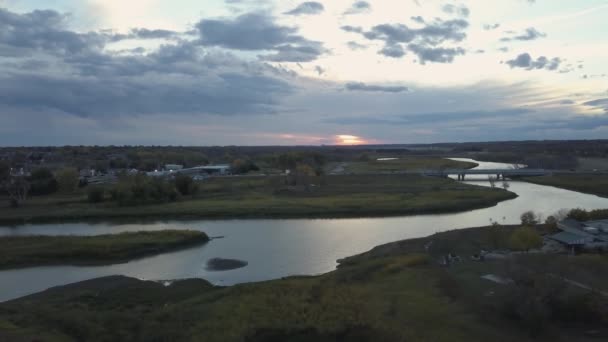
[196,13,325,62]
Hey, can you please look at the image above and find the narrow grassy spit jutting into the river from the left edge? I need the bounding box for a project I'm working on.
[0,230,209,269]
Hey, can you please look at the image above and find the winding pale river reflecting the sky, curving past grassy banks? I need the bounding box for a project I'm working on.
[0,159,608,301]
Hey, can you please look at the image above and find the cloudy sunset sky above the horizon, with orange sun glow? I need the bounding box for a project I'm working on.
[0,0,608,146]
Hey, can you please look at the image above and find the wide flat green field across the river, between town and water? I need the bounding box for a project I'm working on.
[0,175,516,224]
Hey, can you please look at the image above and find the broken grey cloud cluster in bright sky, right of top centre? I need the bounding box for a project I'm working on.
[342,19,469,64]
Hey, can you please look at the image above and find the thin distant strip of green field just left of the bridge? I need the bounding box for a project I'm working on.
[334,157,477,174]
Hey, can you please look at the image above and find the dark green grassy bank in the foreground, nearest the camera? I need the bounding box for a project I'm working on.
[0,227,608,342]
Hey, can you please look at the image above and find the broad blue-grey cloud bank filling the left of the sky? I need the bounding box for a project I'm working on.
[0,10,296,120]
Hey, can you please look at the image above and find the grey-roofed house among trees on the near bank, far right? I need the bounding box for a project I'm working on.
[549,219,608,251]
